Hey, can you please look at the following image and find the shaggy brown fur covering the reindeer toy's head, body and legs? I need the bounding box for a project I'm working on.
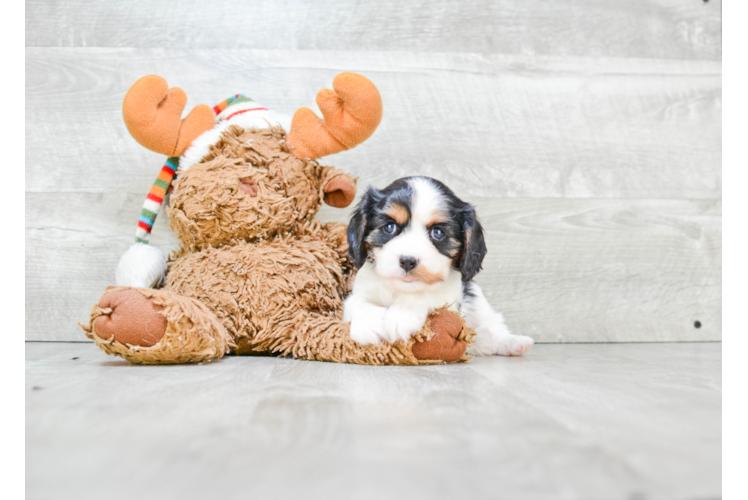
[85,126,474,365]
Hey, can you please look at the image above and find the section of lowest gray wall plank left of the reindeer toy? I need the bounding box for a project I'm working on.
[24,187,178,341]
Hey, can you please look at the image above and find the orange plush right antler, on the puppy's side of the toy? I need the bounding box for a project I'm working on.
[288,73,382,159]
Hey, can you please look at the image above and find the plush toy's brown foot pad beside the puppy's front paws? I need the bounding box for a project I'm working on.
[411,309,475,363]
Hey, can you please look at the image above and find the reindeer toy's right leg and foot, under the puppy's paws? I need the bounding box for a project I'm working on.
[252,309,475,365]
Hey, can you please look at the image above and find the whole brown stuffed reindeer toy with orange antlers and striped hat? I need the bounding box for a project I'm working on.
[83,73,474,365]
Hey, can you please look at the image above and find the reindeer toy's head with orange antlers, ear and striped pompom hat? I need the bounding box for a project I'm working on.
[117,73,382,287]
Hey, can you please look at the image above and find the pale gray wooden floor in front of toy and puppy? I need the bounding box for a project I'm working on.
[25,343,724,500]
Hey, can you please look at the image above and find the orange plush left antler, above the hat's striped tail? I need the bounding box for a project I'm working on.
[122,75,216,156]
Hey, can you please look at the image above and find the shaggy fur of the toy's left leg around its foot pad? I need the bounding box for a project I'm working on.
[81,287,234,365]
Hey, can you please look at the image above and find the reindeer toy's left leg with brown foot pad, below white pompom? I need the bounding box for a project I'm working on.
[81,287,233,364]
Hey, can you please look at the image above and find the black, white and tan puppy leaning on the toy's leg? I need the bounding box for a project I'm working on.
[343,177,533,356]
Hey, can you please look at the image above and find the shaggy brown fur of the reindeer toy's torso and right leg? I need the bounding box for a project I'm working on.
[166,222,474,365]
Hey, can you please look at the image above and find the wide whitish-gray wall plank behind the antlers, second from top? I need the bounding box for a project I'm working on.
[25,47,718,199]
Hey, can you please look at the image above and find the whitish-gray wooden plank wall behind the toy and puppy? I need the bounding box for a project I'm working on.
[24,0,732,342]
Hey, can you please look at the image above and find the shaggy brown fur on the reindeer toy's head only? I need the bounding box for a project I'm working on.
[167,126,355,251]
